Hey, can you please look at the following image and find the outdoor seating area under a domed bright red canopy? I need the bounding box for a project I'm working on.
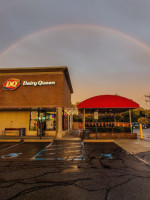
[77,95,139,139]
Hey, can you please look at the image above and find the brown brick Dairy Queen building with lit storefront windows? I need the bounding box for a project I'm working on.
[0,67,73,138]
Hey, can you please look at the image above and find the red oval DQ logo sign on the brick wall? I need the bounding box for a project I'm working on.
[3,78,21,90]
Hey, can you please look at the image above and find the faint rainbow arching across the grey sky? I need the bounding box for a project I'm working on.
[0,24,150,59]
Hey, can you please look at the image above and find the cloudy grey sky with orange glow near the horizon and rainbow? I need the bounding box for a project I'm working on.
[0,0,150,109]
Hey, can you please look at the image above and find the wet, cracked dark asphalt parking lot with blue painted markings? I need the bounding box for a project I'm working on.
[0,141,150,200]
